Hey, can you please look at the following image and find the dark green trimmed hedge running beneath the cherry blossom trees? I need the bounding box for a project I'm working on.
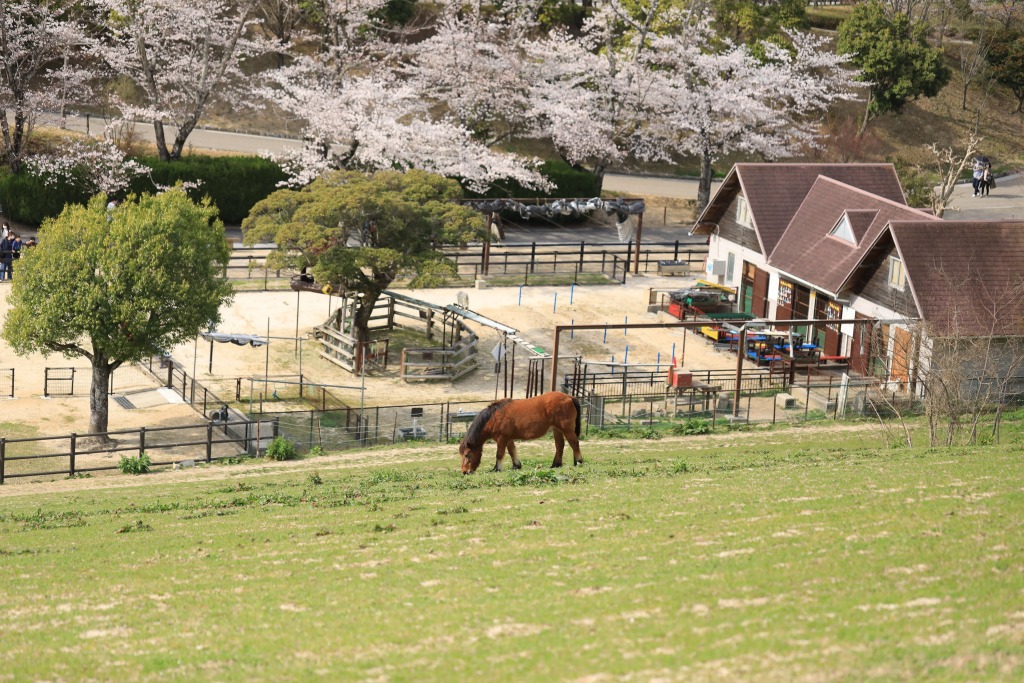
[0,156,597,226]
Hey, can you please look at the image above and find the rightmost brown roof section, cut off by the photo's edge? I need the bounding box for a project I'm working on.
[889,221,1024,337]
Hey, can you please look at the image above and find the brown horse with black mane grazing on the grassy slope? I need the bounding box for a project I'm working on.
[459,391,583,474]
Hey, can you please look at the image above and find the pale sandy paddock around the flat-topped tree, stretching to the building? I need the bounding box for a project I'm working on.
[172,276,735,405]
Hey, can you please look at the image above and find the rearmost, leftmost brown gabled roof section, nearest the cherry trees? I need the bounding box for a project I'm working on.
[690,164,906,256]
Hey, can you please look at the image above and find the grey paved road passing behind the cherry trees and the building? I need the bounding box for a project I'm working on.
[44,117,1024,223]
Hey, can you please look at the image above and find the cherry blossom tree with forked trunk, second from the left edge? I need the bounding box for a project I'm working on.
[95,0,269,161]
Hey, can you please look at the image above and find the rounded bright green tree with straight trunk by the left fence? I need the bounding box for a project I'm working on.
[2,188,231,434]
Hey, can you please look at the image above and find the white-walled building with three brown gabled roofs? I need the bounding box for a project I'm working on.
[691,164,1024,395]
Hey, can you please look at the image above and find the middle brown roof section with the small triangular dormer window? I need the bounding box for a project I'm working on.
[768,176,941,295]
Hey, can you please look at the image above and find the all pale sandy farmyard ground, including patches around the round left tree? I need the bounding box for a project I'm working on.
[0,276,735,436]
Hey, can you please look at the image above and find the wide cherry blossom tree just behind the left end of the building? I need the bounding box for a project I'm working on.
[527,0,855,208]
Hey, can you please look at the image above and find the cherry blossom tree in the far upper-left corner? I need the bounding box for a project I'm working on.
[0,0,90,172]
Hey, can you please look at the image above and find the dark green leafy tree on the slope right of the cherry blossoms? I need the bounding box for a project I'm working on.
[838,0,952,133]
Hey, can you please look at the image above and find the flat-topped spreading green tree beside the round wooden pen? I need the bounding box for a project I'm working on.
[242,171,487,369]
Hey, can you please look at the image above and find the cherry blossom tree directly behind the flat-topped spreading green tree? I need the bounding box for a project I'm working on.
[261,0,545,189]
